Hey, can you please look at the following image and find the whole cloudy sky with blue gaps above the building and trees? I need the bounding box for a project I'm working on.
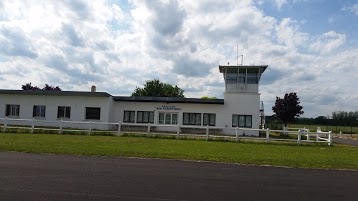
[0,0,358,117]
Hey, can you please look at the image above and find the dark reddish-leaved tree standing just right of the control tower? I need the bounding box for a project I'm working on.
[272,92,304,127]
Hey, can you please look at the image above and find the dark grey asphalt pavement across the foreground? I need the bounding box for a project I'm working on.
[0,152,358,201]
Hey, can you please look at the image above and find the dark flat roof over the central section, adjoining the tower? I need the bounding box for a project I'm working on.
[113,96,224,104]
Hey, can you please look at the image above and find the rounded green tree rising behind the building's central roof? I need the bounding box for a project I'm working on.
[132,79,184,98]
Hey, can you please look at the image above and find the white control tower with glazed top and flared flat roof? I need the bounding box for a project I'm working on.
[219,65,268,130]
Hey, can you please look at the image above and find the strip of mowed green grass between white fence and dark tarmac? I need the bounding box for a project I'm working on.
[0,133,358,170]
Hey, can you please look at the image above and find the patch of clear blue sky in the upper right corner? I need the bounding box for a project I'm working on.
[258,0,358,41]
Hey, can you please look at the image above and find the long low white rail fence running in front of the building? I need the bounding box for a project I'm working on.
[0,117,332,145]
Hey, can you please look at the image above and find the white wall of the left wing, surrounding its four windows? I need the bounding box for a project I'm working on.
[0,90,112,129]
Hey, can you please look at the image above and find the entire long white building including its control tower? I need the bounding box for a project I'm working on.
[0,65,267,135]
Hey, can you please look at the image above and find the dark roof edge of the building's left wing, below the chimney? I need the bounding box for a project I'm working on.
[0,89,111,97]
